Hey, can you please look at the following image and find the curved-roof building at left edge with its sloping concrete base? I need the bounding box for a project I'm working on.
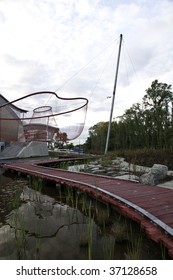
[0,94,48,159]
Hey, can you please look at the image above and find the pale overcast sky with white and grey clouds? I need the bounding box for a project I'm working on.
[0,0,173,142]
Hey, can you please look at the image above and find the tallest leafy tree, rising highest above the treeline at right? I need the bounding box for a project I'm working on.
[143,80,173,148]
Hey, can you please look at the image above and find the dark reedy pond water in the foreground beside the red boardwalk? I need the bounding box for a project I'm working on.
[0,170,168,260]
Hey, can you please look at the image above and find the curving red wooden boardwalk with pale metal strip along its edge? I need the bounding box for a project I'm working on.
[4,158,173,258]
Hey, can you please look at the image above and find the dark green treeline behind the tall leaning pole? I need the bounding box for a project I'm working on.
[85,80,173,153]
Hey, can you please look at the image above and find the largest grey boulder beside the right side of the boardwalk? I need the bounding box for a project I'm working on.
[139,164,168,186]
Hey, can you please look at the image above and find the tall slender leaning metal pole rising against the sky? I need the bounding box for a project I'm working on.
[105,34,123,155]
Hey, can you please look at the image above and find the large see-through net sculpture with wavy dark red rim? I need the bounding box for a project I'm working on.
[0,91,88,143]
